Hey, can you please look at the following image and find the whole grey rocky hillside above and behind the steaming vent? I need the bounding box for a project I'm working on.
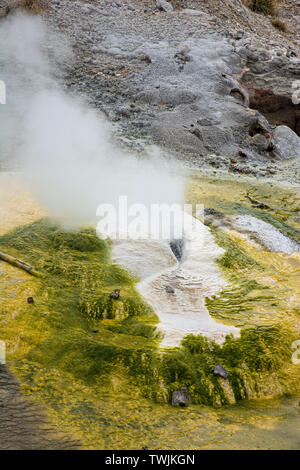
[1,0,300,176]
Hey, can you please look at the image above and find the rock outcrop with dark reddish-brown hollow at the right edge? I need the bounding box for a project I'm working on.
[236,38,300,142]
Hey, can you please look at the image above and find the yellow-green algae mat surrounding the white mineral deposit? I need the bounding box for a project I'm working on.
[0,173,300,449]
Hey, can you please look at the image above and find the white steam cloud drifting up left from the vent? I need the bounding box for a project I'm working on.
[0,14,183,226]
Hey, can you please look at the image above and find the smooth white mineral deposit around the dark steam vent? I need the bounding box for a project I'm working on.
[113,211,239,347]
